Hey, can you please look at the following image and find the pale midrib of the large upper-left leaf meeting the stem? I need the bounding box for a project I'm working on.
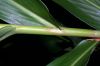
[9,0,56,27]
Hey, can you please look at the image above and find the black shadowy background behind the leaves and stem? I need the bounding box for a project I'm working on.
[0,0,100,66]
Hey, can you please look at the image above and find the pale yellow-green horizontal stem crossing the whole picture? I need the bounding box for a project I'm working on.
[0,24,100,37]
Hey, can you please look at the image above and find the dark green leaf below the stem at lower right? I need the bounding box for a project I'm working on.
[47,40,98,66]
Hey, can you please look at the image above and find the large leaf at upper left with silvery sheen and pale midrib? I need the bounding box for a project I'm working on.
[0,0,60,27]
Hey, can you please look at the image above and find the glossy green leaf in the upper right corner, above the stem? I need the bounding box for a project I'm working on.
[53,0,100,30]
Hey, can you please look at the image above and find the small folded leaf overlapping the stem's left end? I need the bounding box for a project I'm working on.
[0,26,15,41]
